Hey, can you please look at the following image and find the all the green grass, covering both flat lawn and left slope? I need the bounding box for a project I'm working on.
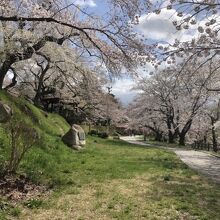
[0,93,220,220]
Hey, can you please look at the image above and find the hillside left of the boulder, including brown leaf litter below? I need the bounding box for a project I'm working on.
[0,92,76,219]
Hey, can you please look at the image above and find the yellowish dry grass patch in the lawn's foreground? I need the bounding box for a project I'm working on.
[21,175,213,220]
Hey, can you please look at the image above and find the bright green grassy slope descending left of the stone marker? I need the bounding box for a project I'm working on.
[0,92,71,184]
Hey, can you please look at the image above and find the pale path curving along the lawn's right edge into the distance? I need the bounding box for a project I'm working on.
[121,136,220,183]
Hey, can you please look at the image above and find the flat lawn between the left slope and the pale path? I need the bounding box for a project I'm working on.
[9,137,220,220]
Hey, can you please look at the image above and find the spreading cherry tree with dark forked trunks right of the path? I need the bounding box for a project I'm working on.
[131,57,213,145]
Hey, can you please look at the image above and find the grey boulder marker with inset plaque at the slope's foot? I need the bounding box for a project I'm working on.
[62,124,86,150]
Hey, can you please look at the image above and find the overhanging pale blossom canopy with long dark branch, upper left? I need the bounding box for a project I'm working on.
[0,0,150,88]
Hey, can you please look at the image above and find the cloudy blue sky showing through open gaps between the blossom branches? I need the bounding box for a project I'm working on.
[75,0,197,104]
